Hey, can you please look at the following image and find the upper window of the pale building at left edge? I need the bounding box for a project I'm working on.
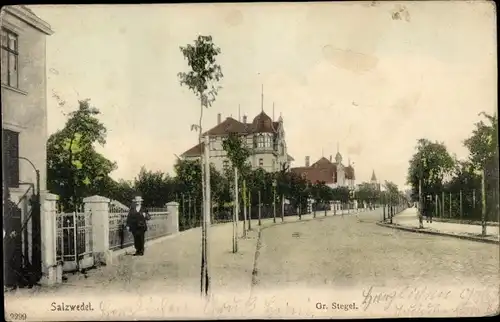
[2,28,19,88]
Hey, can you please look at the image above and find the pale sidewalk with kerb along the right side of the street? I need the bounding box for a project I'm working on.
[385,208,499,243]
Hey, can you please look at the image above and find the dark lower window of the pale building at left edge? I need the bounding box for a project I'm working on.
[2,129,19,188]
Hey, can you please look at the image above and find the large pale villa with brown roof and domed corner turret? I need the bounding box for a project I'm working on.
[181,111,293,172]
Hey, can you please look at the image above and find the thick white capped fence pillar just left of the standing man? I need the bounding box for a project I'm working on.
[83,196,112,265]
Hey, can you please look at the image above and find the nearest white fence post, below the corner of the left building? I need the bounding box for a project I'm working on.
[40,193,62,285]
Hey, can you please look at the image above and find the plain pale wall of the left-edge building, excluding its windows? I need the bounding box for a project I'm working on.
[2,10,47,193]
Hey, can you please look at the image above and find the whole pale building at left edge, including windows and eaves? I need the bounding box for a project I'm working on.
[1,5,53,200]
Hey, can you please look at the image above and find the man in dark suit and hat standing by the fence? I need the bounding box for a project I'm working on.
[127,196,150,256]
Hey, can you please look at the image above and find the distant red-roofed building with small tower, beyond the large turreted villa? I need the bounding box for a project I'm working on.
[291,152,356,190]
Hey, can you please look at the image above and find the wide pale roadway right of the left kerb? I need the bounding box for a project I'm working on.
[254,210,499,315]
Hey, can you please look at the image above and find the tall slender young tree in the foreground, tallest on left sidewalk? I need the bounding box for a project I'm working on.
[177,35,223,295]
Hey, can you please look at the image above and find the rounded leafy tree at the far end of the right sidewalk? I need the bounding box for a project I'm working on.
[407,139,454,200]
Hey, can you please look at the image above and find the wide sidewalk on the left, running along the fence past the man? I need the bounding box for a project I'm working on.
[6,210,360,299]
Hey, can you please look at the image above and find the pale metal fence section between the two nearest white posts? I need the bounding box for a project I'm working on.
[56,207,94,272]
